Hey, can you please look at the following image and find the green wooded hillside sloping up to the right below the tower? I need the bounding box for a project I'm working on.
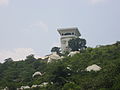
[0,42,120,90]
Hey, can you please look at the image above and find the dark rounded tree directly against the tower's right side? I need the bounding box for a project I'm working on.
[68,38,86,51]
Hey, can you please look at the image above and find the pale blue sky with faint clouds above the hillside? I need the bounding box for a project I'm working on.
[0,0,120,62]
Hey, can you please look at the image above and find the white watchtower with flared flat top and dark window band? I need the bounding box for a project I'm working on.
[58,28,81,53]
